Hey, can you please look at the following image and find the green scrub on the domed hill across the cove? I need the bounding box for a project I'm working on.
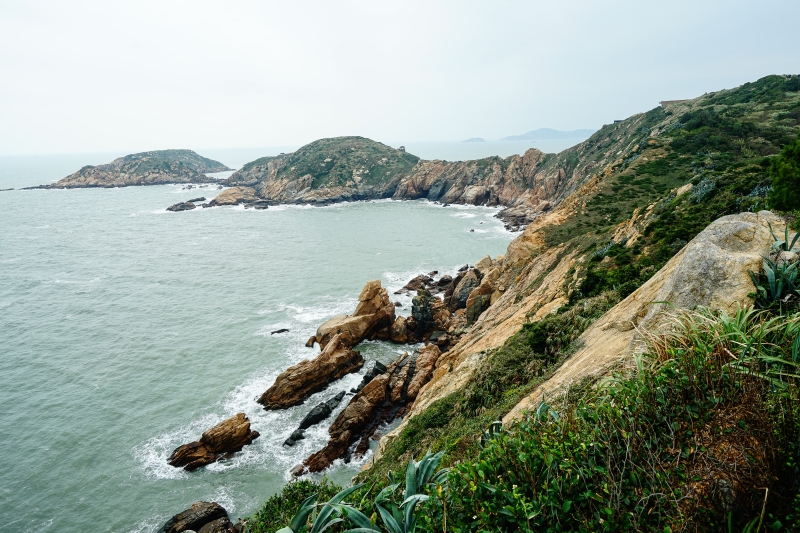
[278,137,419,188]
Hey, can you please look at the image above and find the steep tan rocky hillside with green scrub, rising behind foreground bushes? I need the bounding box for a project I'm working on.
[370,71,800,470]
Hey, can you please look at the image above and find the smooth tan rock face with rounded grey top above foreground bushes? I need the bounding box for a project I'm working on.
[503,211,783,423]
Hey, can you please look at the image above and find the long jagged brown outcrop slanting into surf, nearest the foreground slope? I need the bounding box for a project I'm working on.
[297,344,441,473]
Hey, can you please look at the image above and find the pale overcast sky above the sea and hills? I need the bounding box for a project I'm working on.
[0,0,800,155]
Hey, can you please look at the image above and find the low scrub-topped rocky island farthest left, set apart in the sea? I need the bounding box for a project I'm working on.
[41,150,231,189]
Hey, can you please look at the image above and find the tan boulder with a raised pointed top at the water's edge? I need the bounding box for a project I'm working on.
[316,280,395,348]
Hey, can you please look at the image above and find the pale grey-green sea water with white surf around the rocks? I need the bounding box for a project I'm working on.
[0,152,513,533]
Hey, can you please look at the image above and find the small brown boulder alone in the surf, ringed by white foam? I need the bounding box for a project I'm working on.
[167,413,259,471]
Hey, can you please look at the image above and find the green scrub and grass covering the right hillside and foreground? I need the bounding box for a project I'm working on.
[244,76,800,532]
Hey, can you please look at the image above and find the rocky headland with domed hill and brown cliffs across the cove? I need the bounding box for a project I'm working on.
[214,125,668,227]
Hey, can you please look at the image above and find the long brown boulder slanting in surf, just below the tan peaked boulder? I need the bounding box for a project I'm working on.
[257,334,362,410]
